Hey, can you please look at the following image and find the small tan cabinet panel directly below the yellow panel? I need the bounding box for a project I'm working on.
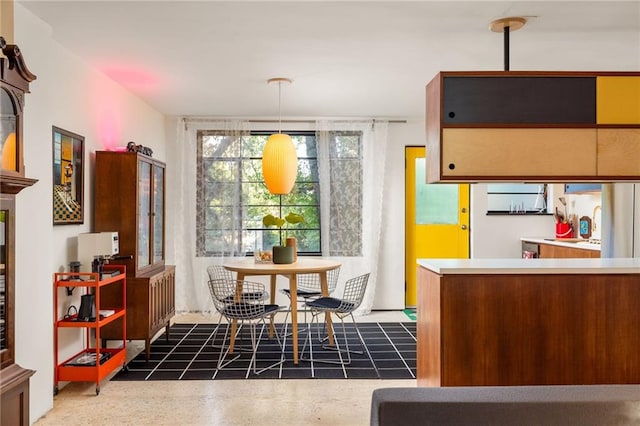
[598,129,640,177]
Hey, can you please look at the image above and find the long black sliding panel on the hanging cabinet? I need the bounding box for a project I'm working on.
[442,76,596,125]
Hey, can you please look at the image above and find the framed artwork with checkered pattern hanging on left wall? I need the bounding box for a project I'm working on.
[53,126,84,225]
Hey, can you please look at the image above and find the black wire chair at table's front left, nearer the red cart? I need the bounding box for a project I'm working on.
[209,279,284,377]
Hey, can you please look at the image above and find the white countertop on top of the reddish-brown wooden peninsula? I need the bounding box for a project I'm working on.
[418,258,640,275]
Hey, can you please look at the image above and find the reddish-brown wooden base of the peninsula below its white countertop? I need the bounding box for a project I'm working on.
[417,268,640,386]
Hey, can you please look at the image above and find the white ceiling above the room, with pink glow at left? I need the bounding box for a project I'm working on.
[15,0,640,119]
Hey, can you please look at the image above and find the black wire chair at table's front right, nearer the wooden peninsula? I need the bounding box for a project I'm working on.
[300,273,371,377]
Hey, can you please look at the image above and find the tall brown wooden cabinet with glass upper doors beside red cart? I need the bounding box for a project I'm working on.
[94,151,175,357]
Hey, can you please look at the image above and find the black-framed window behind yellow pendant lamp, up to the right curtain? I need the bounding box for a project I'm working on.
[196,131,321,256]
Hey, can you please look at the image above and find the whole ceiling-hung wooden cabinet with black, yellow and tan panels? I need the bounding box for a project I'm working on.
[426,71,640,182]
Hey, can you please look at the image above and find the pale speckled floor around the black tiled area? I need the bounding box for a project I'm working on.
[35,311,416,426]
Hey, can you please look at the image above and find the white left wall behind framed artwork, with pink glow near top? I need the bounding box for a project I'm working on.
[15,4,165,421]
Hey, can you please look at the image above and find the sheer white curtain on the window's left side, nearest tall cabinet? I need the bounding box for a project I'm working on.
[174,119,249,312]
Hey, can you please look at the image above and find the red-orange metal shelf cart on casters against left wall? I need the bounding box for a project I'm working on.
[53,265,128,395]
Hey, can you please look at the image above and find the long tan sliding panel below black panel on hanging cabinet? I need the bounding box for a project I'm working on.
[442,128,596,177]
